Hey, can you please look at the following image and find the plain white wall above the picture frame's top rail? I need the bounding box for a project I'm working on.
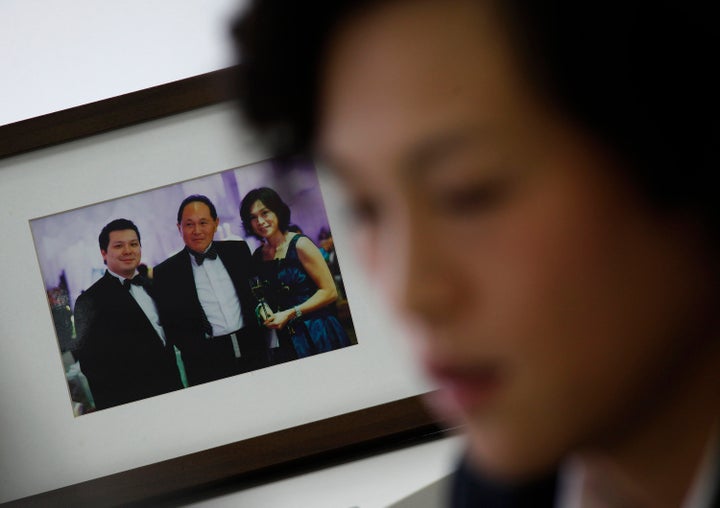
[0,0,244,125]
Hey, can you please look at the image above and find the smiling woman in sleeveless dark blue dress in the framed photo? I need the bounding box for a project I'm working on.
[240,187,350,361]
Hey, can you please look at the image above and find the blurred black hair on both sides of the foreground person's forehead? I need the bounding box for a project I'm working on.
[233,0,720,228]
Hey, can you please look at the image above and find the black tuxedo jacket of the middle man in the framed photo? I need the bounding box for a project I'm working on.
[153,241,267,385]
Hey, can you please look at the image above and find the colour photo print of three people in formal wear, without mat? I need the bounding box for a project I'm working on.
[30,160,357,416]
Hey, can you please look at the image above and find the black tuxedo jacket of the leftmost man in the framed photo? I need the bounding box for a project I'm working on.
[75,272,182,409]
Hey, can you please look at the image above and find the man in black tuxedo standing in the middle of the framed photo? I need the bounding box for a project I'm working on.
[153,195,267,386]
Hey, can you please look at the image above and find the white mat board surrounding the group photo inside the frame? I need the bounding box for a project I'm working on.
[0,104,430,504]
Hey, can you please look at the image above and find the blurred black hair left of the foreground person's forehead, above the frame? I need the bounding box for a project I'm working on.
[233,0,378,156]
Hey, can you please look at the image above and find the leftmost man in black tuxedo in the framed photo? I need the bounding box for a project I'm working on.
[74,219,182,409]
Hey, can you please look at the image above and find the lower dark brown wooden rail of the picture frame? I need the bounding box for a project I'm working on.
[7,396,438,508]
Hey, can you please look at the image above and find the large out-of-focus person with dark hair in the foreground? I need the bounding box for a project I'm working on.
[235,0,720,508]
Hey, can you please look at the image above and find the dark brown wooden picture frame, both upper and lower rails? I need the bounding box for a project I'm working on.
[0,69,444,506]
